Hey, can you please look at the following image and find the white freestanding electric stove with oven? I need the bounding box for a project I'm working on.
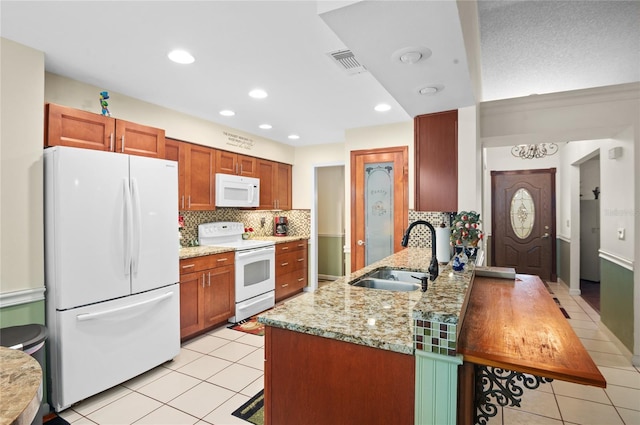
[198,221,276,323]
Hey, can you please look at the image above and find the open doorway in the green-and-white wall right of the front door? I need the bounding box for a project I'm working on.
[580,155,600,312]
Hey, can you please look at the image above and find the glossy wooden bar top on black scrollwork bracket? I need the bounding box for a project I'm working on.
[458,274,607,388]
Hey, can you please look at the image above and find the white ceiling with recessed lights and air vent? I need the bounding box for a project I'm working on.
[0,0,640,146]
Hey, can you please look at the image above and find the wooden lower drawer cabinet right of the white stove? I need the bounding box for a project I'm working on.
[276,239,308,302]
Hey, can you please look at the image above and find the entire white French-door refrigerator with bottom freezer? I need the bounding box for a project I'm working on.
[44,146,180,411]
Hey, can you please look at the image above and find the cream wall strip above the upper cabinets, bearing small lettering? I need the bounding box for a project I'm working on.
[45,73,294,164]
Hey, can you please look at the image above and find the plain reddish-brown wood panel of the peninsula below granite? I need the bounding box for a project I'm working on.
[264,326,415,425]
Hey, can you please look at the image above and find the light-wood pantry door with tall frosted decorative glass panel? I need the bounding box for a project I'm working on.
[351,146,409,270]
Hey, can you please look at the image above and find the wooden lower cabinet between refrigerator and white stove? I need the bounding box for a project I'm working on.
[180,252,235,341]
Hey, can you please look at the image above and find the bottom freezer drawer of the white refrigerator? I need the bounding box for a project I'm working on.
[48,284,180,411]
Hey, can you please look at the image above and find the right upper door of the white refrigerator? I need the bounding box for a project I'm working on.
[130,156,179,293]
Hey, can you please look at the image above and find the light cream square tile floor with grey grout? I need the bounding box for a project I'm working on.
[60,283,640,425]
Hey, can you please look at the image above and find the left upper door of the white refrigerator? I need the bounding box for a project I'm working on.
[44,146,131,309]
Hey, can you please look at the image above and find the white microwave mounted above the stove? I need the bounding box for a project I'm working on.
[216,173,260,208]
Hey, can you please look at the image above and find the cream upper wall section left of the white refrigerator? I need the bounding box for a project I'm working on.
[0,38,44,294]
